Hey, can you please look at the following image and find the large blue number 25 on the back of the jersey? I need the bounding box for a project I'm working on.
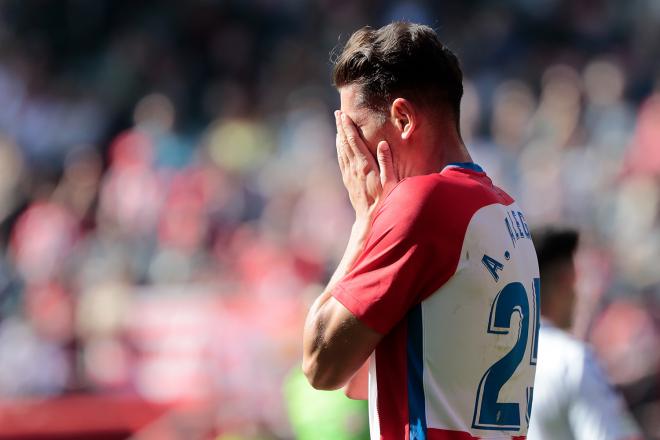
[472,278,540,431]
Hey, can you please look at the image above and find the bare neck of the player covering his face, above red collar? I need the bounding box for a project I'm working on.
[397,126,472,179]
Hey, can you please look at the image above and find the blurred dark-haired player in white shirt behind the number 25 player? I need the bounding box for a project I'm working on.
[529,227,641,440]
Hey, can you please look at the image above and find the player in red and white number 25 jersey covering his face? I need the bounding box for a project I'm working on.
[303,22,539,440]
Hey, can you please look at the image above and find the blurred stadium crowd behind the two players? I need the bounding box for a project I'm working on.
[0,0,660,439]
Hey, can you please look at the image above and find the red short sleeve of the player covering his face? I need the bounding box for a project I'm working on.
[332,181,460,334]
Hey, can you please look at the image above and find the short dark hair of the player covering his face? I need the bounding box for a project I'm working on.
[332,21,463,124]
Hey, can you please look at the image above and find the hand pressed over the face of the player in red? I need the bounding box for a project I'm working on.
[335,110,399,224]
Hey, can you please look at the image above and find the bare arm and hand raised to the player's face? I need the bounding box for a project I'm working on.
[303,113,395,390]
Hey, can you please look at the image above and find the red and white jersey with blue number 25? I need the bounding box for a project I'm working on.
[332,163,540,440]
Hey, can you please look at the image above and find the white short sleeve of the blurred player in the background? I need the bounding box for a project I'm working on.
[568,350,639,440]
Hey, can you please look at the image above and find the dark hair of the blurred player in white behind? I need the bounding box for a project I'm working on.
[532,226,579,277]
